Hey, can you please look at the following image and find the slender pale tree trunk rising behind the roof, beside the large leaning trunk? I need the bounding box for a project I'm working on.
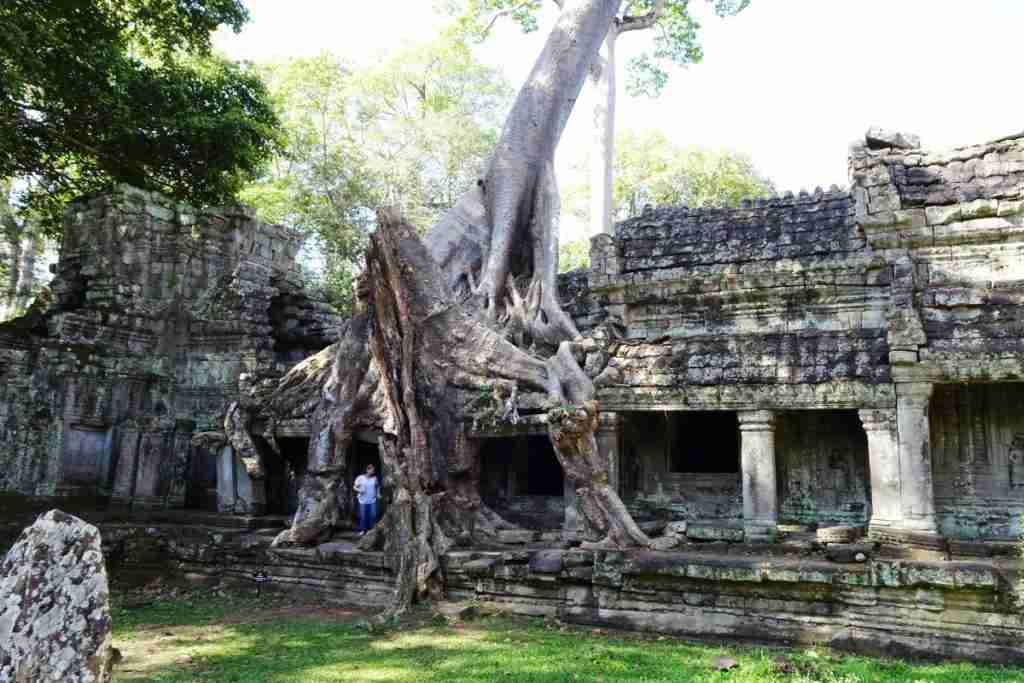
[590,24,618,237]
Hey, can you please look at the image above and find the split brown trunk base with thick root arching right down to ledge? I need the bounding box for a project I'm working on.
[352,211,649,610]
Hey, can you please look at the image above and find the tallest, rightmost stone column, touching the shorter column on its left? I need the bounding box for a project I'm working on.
[896,382,938,533]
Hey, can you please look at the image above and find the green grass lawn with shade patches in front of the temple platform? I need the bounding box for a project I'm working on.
[115,608,1024,683]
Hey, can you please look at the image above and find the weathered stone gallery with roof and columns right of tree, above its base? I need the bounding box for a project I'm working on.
[589,129,1024,547]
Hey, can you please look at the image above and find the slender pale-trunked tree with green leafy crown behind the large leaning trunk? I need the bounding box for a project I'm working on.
[446,0,750,234]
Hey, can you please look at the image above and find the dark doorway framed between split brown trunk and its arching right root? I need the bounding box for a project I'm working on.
[480,434,565,530]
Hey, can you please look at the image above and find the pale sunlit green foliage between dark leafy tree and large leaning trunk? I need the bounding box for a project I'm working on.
[242,37,511,308]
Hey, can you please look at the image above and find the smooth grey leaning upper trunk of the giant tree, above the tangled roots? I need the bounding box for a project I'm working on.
[426,0,621,345]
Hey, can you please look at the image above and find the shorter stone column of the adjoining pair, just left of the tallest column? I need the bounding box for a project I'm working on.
[859,410,903,536]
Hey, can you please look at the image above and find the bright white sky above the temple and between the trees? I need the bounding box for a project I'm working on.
[216,0,1024,235]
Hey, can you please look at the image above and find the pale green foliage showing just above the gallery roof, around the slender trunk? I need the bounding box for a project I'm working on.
[562,131,774,220]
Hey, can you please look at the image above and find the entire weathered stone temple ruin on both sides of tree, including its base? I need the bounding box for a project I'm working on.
[0,129,1024,661]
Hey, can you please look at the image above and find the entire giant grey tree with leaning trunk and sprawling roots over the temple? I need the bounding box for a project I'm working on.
[268,0,649,611]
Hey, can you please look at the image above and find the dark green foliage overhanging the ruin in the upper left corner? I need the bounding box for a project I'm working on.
[0,0,278,234]
